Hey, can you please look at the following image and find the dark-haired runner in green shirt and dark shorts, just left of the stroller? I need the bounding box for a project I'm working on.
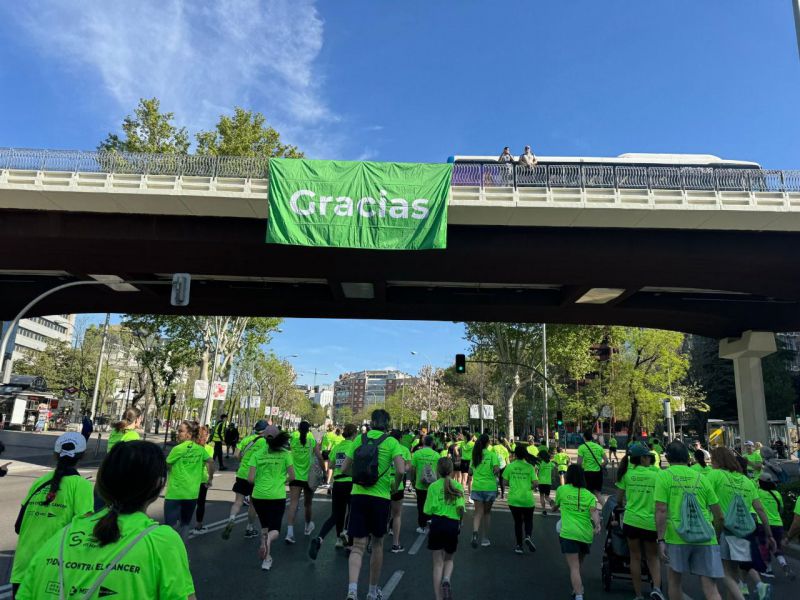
[556,465,600,598]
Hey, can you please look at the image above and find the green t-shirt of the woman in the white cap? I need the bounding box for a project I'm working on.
[11,473,94,583]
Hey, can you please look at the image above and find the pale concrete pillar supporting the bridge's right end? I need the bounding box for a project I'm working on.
[719,331,777,446]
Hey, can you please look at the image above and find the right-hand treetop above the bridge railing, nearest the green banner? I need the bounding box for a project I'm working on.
[195,106,303,158]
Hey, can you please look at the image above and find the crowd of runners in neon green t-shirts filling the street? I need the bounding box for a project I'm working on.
[6,408,800,600]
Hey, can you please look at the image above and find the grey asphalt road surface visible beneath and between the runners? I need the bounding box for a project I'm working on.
[0,434,800,600]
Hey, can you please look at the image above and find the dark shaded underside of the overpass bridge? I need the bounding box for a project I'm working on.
[0,210,800,337]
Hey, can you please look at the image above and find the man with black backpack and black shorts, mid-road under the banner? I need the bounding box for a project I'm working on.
[342,409,405,600]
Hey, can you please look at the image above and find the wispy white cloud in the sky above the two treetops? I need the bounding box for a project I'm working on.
[16,0,334,154]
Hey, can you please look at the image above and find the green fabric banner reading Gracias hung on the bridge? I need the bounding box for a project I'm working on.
[267,158,446,250]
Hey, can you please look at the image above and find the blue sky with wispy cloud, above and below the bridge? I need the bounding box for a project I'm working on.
[0,0,800,381]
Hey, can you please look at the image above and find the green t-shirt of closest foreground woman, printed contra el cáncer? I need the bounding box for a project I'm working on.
[17,510,194,600]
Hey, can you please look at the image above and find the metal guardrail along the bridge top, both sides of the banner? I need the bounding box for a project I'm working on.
[0,148,800,192]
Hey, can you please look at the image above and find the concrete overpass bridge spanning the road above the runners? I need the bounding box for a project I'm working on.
[0,149,800,442]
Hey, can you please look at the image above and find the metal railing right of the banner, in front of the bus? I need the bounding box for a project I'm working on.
[453,163,800,192]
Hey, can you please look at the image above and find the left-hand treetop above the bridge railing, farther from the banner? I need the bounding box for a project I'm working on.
[97,98,189,154]
